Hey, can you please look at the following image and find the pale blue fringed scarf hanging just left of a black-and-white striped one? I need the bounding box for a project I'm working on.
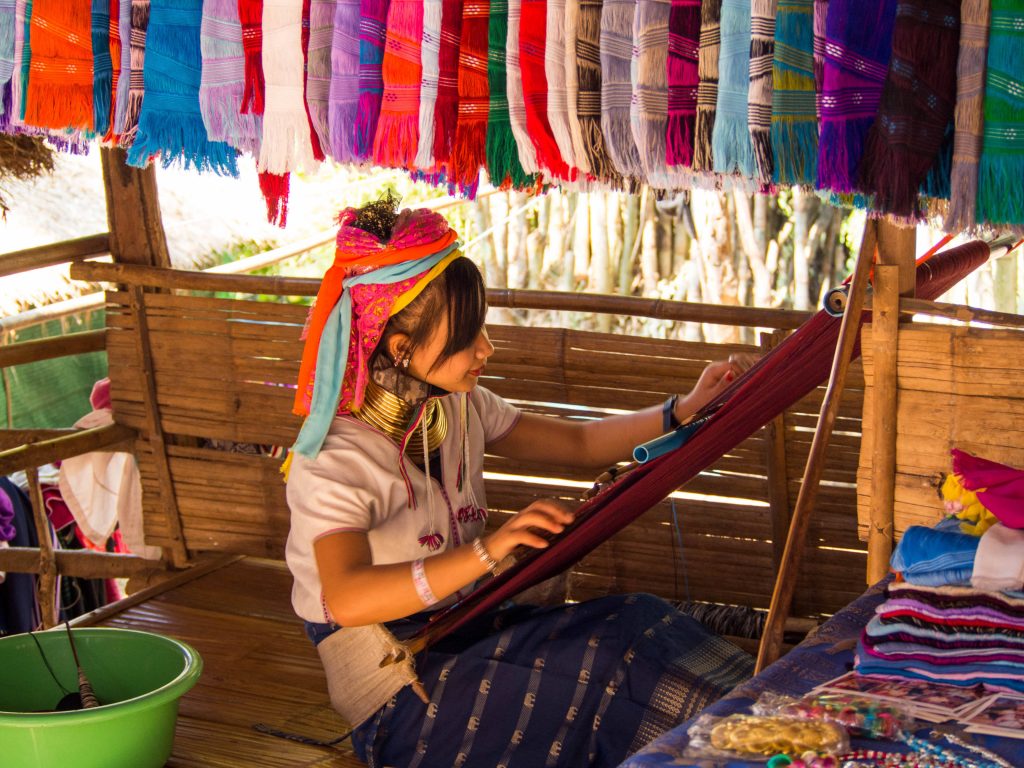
[712,0,757,177]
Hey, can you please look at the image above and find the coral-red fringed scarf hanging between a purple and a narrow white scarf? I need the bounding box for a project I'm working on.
[374,0,423,168]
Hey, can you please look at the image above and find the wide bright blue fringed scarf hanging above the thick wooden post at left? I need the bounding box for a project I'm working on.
[128,0,239,176]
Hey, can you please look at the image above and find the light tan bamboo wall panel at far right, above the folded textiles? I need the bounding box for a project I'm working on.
[857,324,1024,540]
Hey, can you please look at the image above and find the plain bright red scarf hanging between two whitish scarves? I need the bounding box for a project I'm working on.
[519,0,569,179]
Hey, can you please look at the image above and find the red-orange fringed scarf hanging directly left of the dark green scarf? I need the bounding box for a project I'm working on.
[447,0,490,191]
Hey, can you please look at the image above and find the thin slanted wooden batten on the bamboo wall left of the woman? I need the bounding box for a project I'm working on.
[129,286,188,567]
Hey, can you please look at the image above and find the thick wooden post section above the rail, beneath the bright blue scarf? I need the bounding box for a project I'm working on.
[99,146,171,267]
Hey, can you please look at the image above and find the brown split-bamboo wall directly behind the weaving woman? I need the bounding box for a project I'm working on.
[108,293,864,615]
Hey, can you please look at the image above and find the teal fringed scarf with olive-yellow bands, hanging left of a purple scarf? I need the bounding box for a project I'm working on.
[771,0,818,184]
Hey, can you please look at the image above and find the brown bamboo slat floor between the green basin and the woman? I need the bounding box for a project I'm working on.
[76,558,364,768]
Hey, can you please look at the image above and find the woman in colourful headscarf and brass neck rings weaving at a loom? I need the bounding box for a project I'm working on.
[287,198,752,768]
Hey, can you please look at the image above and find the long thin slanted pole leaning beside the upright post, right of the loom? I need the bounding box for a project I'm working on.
[757,219,878,672]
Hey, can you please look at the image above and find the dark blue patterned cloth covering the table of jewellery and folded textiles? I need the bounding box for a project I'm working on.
[620,582,1024,768]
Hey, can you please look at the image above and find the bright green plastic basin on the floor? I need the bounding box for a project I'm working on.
[0,628,203,768]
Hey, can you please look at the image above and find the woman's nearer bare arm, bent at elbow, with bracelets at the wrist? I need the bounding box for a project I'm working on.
[313,499,572,627]
